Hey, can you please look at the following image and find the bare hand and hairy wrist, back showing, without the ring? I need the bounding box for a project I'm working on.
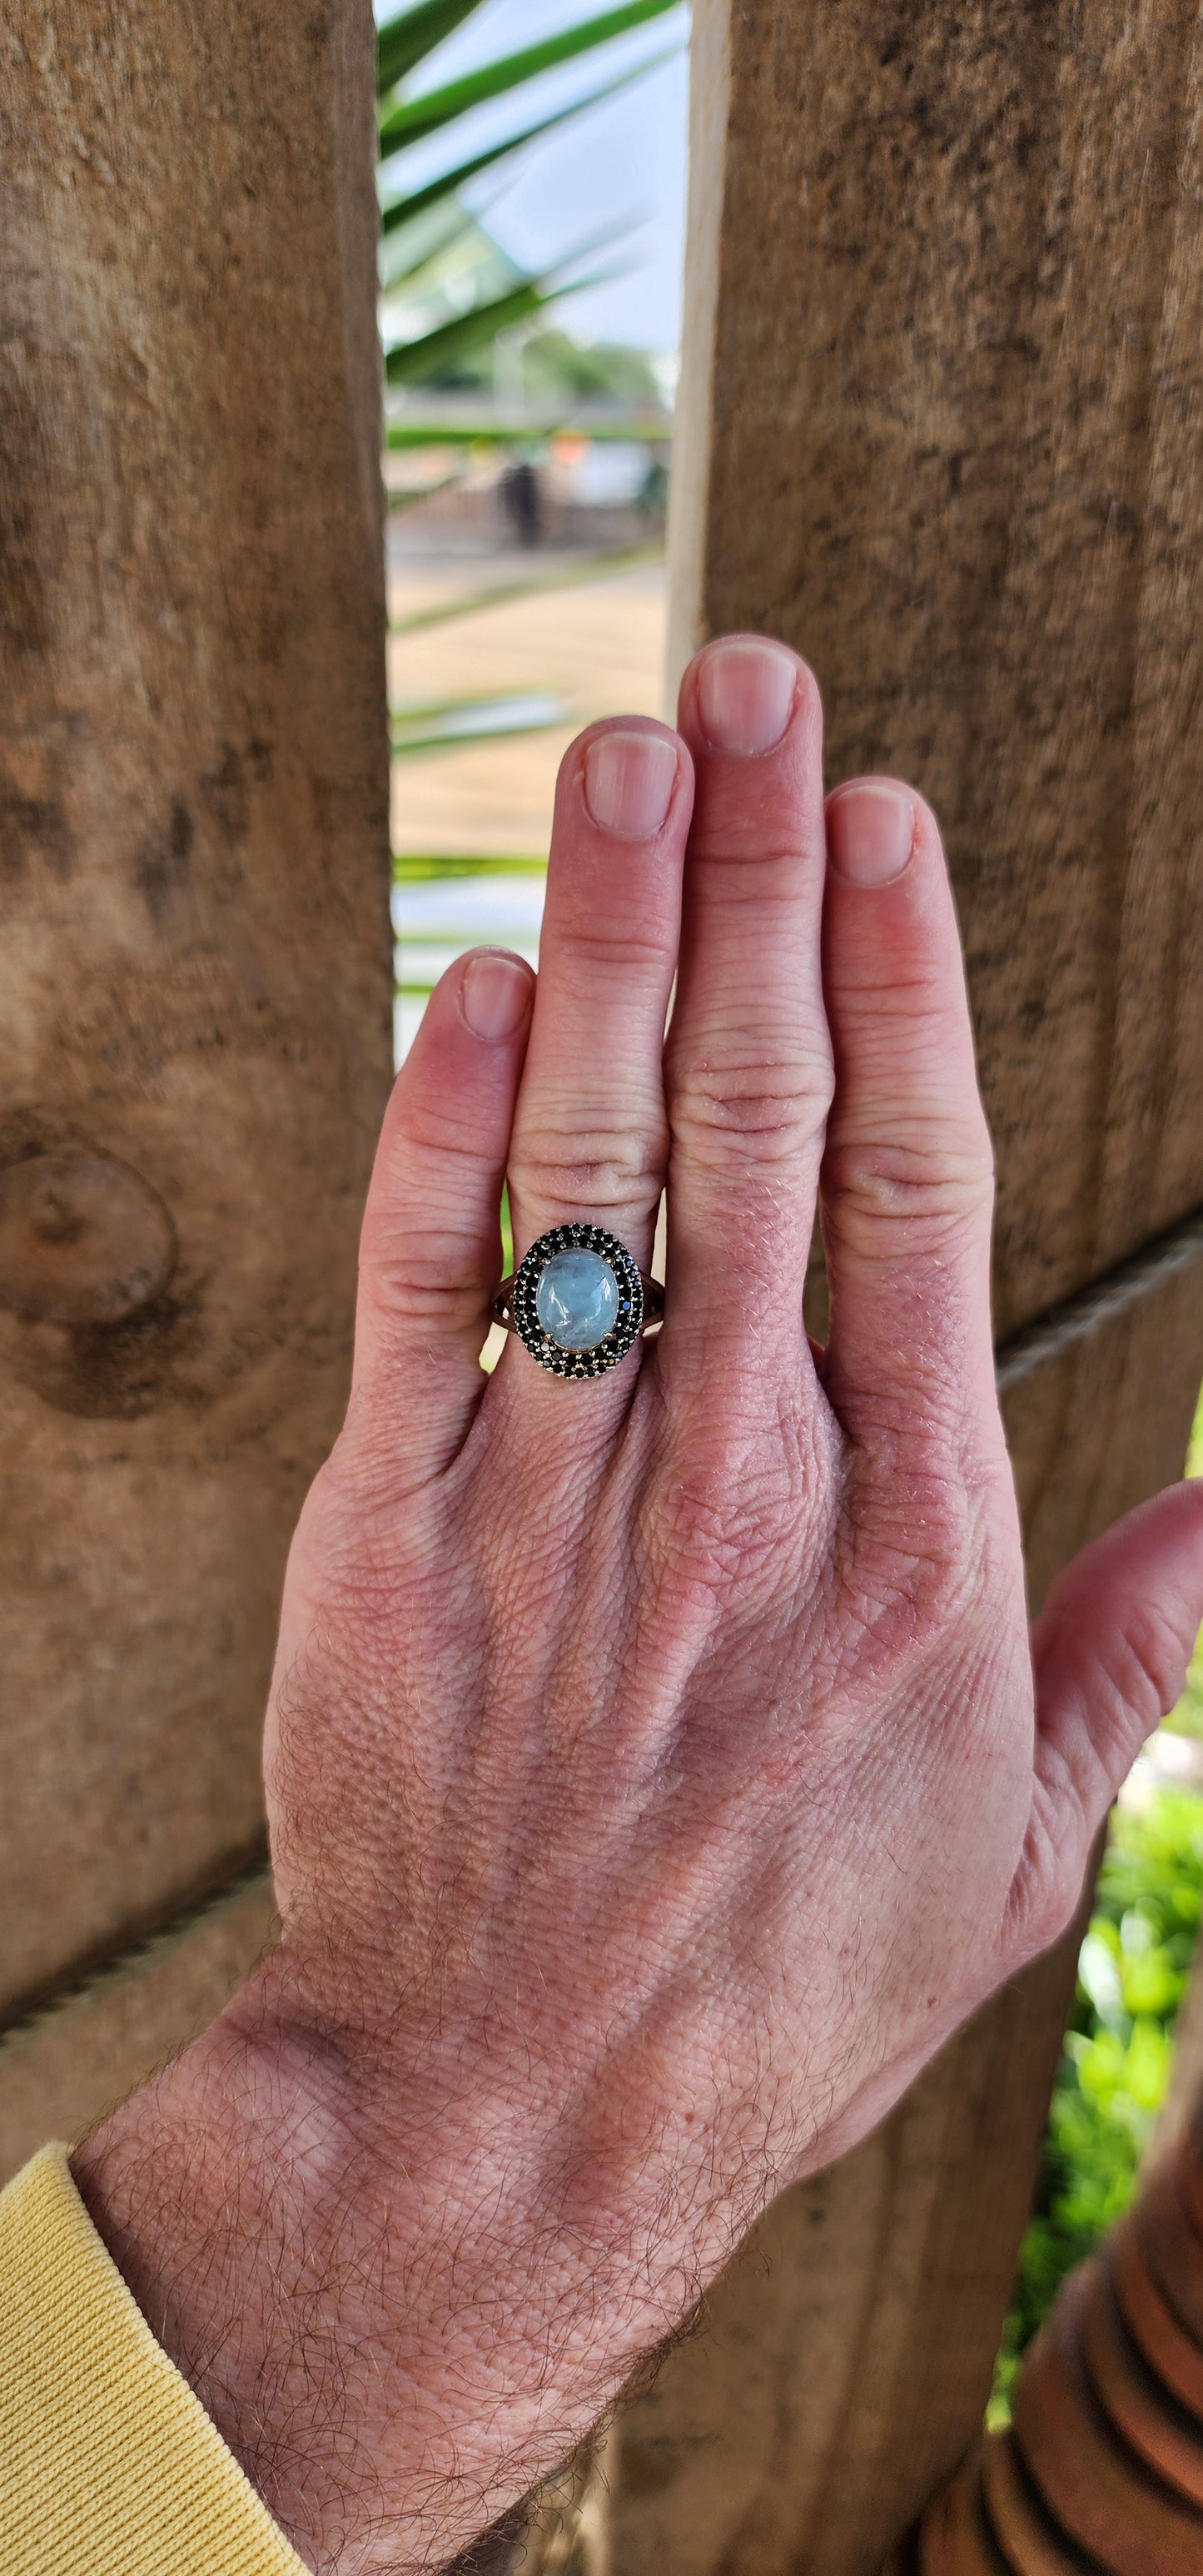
[77,639,1203,2576]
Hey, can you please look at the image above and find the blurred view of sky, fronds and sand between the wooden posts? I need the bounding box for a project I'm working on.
[379,0,688,1053]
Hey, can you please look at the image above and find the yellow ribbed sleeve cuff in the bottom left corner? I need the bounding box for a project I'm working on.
[0,2146,304,2576]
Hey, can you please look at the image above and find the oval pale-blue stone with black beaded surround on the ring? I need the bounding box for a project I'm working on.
[492,1221,664,1378]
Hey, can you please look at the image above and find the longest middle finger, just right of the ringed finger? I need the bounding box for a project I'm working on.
[664,636,832,1368]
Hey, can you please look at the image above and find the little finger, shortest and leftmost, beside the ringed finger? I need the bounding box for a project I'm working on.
[350,948,536,1484]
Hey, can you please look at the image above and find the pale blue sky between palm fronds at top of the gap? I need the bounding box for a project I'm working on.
[386,0,688,356]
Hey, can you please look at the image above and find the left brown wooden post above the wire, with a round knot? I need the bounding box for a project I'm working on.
[0,0,391,2012]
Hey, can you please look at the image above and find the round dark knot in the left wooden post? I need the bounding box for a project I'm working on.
[0,1146,178,1324]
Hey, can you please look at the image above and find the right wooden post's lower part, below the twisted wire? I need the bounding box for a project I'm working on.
[613,1241,1203,2576]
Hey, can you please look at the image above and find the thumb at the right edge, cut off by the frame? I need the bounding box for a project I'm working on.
[1015,1479,1203,1947]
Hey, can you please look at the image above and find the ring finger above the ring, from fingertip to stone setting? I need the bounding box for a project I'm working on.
[510,716,693,1267]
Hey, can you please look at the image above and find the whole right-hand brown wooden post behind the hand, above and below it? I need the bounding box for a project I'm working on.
[616,0,1203,2576]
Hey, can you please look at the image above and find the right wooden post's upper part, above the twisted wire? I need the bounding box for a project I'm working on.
[673,0,1203,1332]
